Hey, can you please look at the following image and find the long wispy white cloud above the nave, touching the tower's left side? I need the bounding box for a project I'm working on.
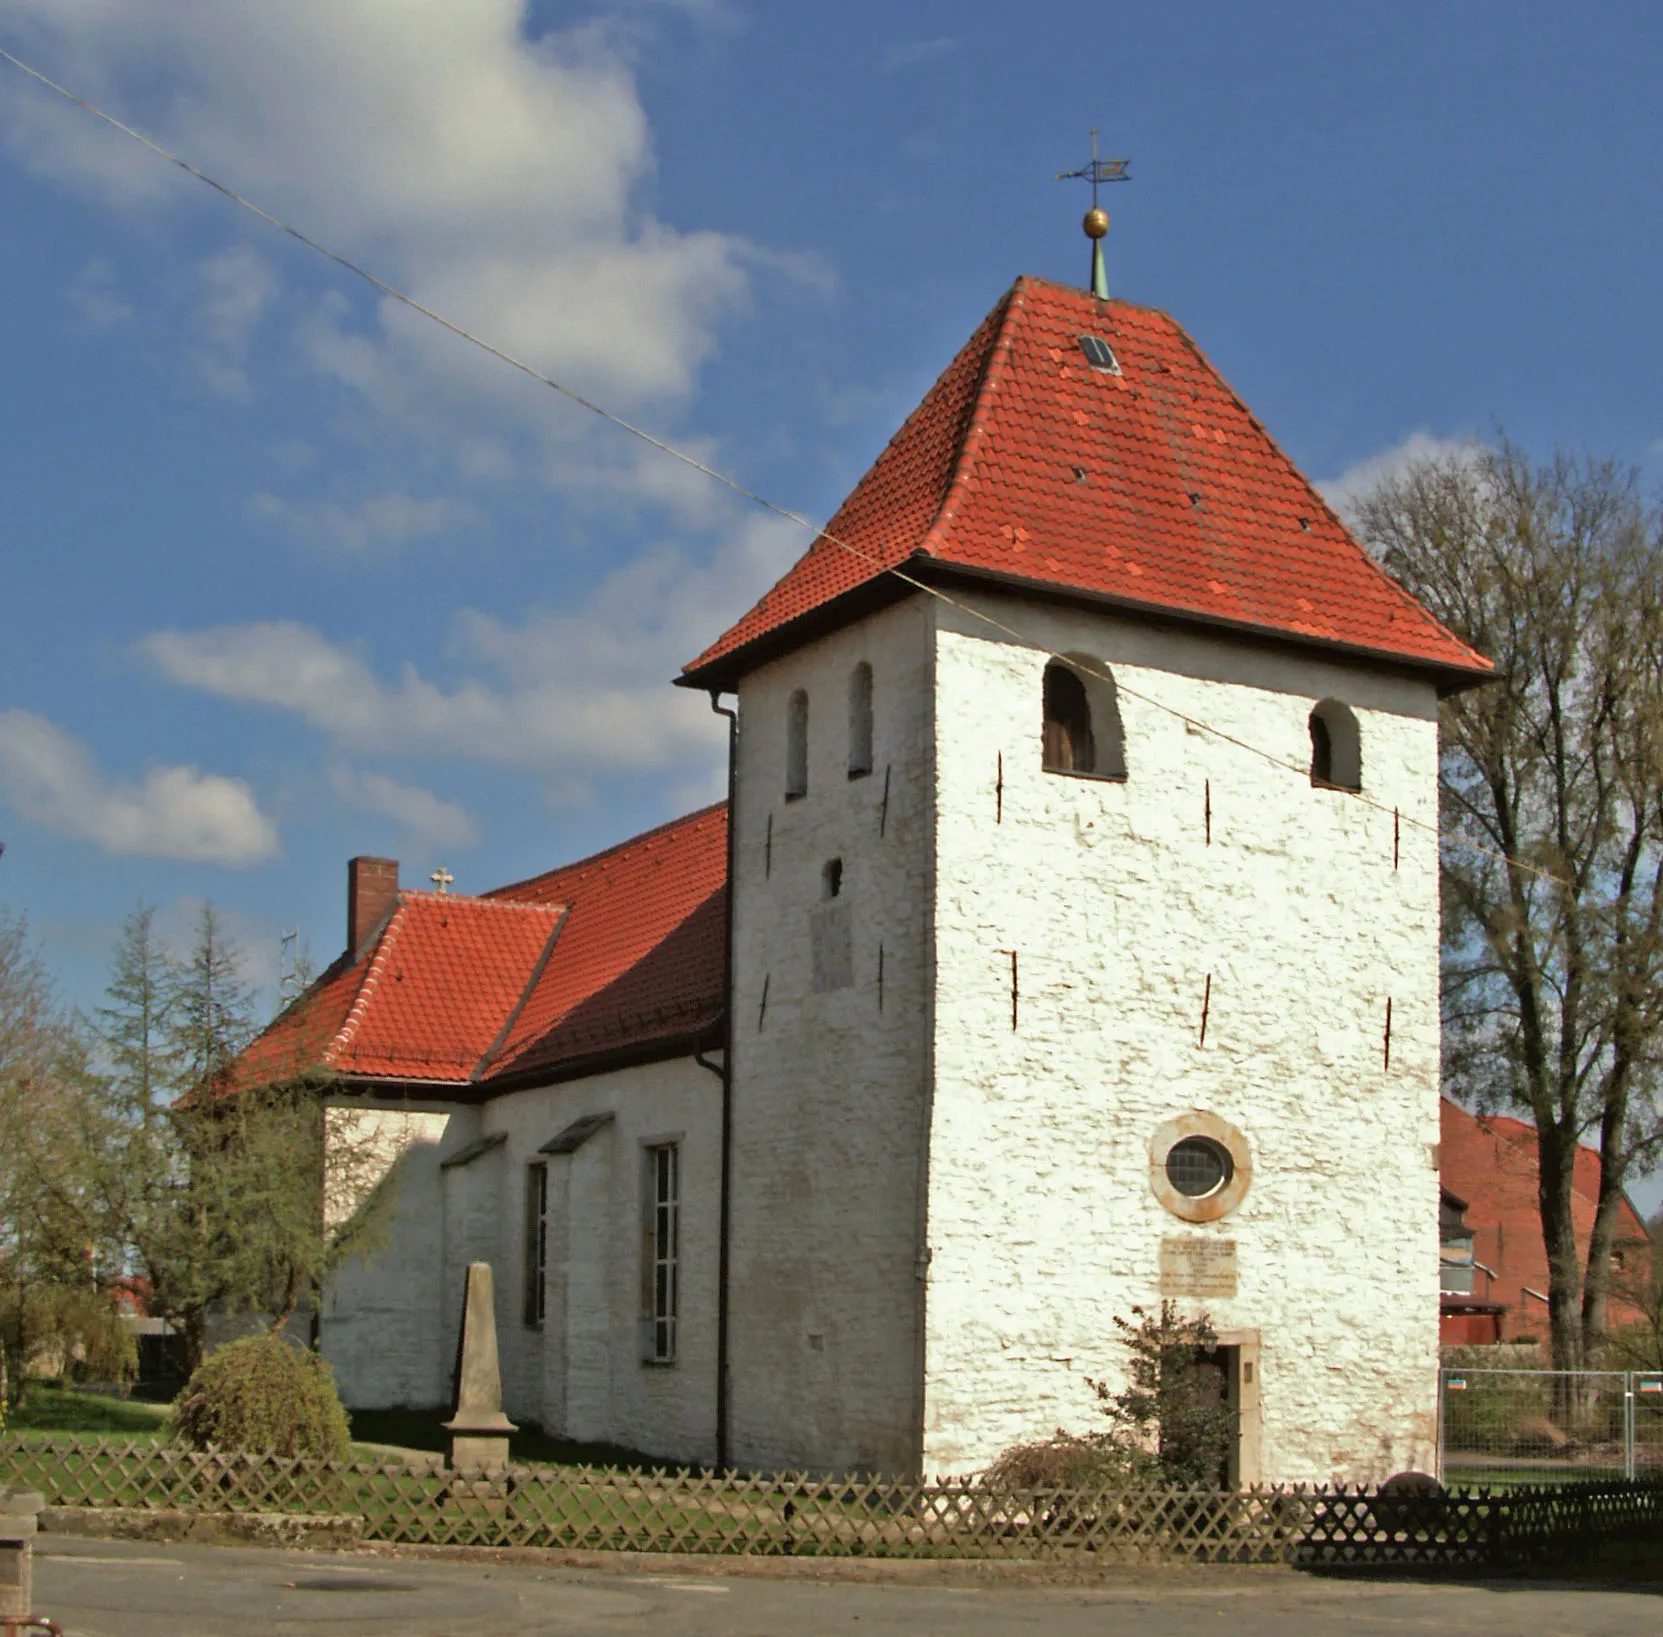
[140,519,803,784]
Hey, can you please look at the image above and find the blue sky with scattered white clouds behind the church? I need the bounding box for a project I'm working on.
[0,0,1663,1051]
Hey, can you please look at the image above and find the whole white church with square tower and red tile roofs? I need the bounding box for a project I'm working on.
[238,266,1490,1482]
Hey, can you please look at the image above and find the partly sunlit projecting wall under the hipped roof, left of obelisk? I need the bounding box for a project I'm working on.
[319,1101,477,1409]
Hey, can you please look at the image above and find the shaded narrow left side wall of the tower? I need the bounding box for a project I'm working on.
[730,599,933,1472]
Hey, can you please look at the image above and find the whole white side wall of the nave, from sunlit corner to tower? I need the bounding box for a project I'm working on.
[323,1058,722,1461]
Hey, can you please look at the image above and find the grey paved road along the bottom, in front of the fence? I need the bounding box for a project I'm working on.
[25,1537,1663,1637]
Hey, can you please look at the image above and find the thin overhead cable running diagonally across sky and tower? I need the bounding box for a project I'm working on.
[0,48,1568,885]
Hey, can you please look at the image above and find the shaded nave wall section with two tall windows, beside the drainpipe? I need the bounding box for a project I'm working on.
[476,1056,722,1461]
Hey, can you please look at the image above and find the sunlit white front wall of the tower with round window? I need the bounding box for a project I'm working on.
[925,597,1438,1481]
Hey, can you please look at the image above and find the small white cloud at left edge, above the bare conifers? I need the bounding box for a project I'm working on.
[0,710,278,865]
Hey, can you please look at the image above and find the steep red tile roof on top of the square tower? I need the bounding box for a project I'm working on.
[682,278,1492,687]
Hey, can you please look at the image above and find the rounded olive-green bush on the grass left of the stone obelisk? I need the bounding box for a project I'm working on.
[173,1334,351,1461]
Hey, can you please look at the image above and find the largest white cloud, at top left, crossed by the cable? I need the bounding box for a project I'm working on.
[0,0,750,422]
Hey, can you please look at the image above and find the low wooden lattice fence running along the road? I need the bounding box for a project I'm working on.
[0,1437,1663,1567]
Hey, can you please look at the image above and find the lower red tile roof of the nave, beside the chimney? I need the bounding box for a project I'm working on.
[221,805,727,1091]
